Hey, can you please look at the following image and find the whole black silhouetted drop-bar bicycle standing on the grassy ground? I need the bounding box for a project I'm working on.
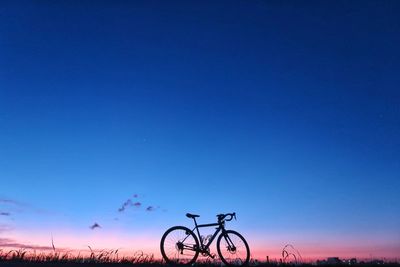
[160,213,250,266]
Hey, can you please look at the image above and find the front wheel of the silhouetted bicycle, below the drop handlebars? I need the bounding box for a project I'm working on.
[217,230,250,266]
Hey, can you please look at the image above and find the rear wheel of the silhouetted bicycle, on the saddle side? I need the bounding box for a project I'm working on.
[160,226,199,264]
